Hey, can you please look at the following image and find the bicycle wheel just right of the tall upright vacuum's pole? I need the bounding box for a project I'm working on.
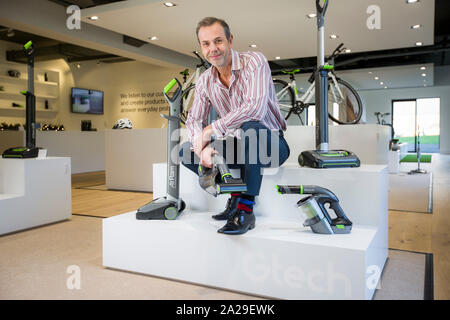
[328,79,362,124]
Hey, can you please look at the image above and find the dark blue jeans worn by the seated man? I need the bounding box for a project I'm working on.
[180,121,290,196]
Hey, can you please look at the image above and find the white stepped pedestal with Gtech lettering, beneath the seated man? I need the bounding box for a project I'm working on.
[103,164,388,299]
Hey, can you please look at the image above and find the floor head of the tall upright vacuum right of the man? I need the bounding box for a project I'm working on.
[298,150,361,168]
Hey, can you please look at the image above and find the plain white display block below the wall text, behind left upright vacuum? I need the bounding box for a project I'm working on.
[105,129,171,192]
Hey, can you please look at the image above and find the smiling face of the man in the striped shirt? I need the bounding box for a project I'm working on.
[198,23,233,68]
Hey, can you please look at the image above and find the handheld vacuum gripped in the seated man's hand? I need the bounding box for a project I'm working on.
[198,153,247,197]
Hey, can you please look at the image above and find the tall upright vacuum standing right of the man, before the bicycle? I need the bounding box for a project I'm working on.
[298,0,360,168]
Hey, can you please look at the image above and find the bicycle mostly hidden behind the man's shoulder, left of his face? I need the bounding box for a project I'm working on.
[180,51,211,124]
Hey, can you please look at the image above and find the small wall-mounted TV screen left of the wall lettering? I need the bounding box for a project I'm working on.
[72,88,103,114]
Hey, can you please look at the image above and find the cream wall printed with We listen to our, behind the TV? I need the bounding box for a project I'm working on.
[0,40,192,131]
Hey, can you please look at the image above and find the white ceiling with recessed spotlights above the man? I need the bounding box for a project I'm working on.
[82,0,434,60]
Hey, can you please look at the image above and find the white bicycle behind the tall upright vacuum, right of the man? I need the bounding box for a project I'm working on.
[273,43,362,125]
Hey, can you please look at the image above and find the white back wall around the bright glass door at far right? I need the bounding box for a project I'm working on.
[358,85,450,154]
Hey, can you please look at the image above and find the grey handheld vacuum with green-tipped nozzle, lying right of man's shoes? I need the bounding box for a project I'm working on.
[275,185,353,234]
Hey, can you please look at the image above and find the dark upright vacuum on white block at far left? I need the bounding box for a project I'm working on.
[2,41,39,159]
